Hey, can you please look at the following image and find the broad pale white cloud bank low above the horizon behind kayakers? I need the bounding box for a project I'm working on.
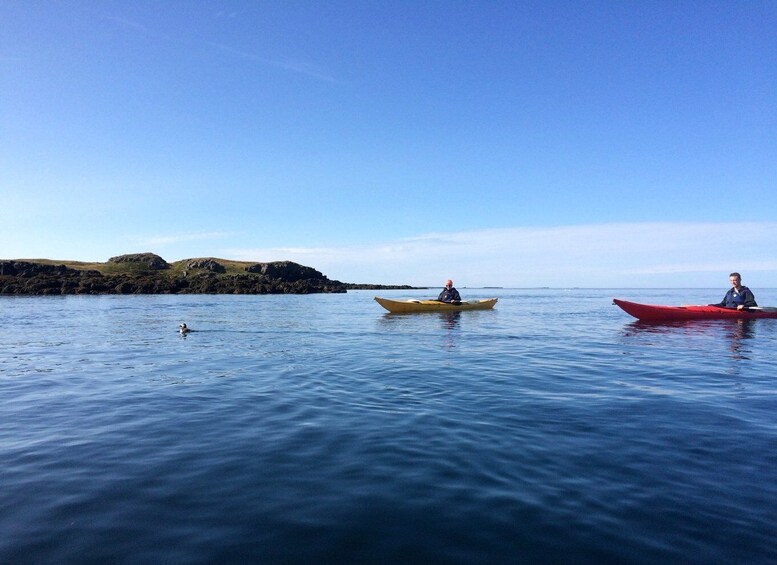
[225,222,777,287]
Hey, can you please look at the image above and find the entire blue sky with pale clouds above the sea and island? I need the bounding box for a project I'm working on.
[0,0,777,288]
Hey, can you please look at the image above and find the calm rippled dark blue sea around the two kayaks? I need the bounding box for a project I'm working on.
[0,287,777,564]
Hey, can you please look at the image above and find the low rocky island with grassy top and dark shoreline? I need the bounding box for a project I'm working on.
[0,253,417,295]
